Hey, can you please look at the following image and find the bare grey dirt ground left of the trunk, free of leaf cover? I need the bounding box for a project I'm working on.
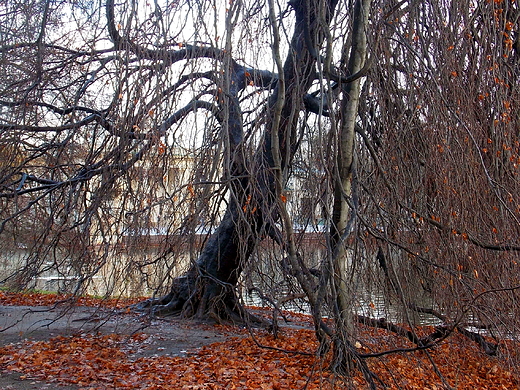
[0,306,232,390]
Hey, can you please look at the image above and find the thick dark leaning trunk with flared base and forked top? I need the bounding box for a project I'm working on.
[140,0,336,321]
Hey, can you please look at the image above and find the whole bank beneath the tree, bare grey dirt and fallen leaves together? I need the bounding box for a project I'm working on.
[0,293,519,390]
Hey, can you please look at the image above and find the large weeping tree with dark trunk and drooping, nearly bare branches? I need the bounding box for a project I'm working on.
[0,0,520,387]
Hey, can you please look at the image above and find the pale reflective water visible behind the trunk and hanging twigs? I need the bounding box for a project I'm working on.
[0,242,440,325]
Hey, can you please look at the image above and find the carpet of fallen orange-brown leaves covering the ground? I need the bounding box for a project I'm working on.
[0,292,520,390]
